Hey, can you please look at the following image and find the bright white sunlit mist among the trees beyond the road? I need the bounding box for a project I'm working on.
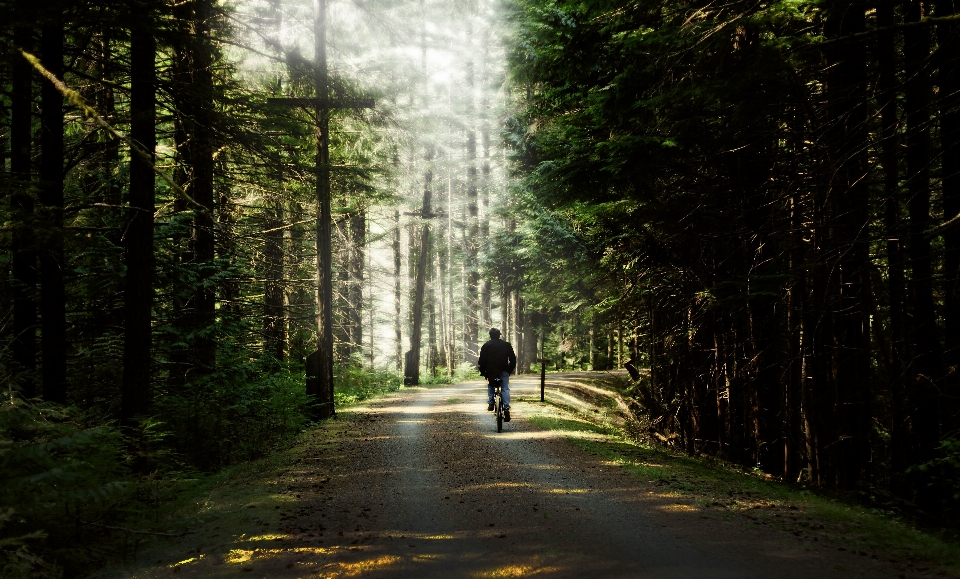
[237,2,522,373]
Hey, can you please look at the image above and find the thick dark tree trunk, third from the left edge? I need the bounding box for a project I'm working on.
[120,19,157,425]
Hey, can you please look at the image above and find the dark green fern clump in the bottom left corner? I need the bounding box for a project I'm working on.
[0,395,134,578]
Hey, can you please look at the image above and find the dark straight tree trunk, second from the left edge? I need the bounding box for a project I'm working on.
[40,15,67,403]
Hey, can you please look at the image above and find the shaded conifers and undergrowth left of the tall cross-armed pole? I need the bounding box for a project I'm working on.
[0,0,394,577]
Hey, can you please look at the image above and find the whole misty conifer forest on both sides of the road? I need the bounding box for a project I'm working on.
[0,0,960,577]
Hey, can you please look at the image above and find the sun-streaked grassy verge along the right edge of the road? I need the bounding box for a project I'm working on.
[526,399,960,574]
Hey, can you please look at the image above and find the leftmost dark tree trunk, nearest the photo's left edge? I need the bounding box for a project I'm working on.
[10,10,37,398]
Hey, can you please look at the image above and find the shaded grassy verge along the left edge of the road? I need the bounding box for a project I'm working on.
[93,373,420,579]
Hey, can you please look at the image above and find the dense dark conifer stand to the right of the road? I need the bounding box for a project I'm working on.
[506,0,960,518]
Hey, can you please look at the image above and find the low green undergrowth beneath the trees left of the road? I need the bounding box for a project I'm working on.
[0,362,454,579]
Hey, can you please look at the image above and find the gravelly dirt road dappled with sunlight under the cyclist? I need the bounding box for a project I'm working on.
[141,378,916,579]
